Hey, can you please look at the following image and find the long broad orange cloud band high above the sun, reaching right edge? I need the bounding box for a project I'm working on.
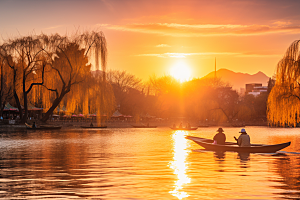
[98,21,300,37]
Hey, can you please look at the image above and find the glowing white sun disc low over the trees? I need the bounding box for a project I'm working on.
[170,61,191,83]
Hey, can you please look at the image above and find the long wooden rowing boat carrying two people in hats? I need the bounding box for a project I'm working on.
[186,136,291,153]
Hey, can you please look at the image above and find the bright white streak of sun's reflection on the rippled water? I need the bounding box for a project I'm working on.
[170,131,191,199]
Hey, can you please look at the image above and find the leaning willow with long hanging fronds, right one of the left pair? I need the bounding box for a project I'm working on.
[42,32,107,121]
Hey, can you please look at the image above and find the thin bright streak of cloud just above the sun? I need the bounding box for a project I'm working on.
[136,52,281,58]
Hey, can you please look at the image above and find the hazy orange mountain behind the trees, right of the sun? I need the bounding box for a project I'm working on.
[203,69,269,91]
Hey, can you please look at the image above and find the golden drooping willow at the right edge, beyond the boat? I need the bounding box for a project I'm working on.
[268,40,300,127]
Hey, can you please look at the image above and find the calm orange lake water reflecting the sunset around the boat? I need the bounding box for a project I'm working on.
[0,127,300,200]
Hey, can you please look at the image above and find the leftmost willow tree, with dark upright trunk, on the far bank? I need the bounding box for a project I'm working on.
[0,35,51,122]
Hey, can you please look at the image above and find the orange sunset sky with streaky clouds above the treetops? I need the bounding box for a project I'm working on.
[0,0,300,80]
